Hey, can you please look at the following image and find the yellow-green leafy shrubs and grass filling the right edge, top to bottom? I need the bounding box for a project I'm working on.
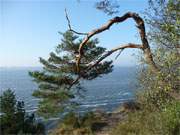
[112,0,180,135]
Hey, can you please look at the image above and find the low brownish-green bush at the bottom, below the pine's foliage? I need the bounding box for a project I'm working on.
[52,112,100,135]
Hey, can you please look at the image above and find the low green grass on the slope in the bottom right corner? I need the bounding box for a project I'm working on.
[112,102,180,135]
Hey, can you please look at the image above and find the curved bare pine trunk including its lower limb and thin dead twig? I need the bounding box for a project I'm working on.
[65,10,160,85]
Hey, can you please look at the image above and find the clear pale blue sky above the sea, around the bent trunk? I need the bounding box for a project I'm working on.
[0,0,147,67]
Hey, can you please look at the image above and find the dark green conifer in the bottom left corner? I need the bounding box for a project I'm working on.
[0,89,44,135]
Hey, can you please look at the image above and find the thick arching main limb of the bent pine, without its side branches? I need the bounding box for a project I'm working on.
[76,12,159,72]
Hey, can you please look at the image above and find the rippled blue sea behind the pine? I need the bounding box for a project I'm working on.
[0,67,137,112]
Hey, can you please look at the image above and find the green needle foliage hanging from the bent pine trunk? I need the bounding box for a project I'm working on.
[30,31,113,117]
